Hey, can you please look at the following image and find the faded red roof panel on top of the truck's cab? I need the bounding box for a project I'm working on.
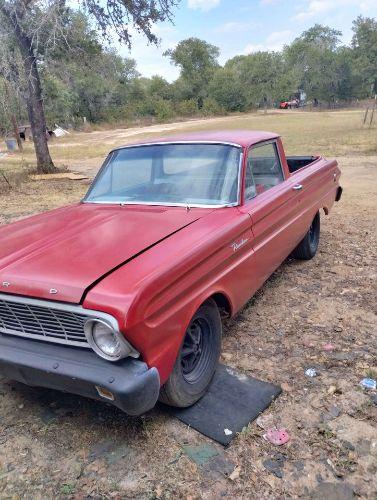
[111,130,279,149]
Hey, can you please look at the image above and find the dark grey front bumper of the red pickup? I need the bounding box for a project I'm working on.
[0,334,160,415]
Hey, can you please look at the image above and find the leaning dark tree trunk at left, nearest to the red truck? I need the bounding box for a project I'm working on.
[23,47,57,174]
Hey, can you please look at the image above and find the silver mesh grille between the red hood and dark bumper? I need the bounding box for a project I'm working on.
[0,295,89,348]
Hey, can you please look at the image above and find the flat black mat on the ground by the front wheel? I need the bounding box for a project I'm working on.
[166,365,281,445]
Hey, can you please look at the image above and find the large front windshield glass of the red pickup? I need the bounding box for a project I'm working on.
[84,144,241,206]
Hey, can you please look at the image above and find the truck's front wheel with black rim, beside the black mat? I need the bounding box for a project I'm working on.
[160,300,222,408]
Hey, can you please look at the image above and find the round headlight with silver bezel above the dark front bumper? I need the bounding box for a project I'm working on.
[84,319,139,361]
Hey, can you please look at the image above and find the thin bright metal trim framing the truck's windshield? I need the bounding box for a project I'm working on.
[81,140,244,208]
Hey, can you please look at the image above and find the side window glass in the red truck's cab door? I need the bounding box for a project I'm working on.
[245,142,284,200]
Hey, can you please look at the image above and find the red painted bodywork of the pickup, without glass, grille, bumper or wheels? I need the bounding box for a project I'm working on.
[0,131,340,383]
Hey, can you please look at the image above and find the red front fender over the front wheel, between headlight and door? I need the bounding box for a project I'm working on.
[84,208,253,383]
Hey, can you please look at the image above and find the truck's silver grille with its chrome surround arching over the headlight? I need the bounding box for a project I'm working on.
[0,293,119,349]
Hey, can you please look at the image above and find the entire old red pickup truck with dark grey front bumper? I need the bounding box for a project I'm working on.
[0,131,342,415]
